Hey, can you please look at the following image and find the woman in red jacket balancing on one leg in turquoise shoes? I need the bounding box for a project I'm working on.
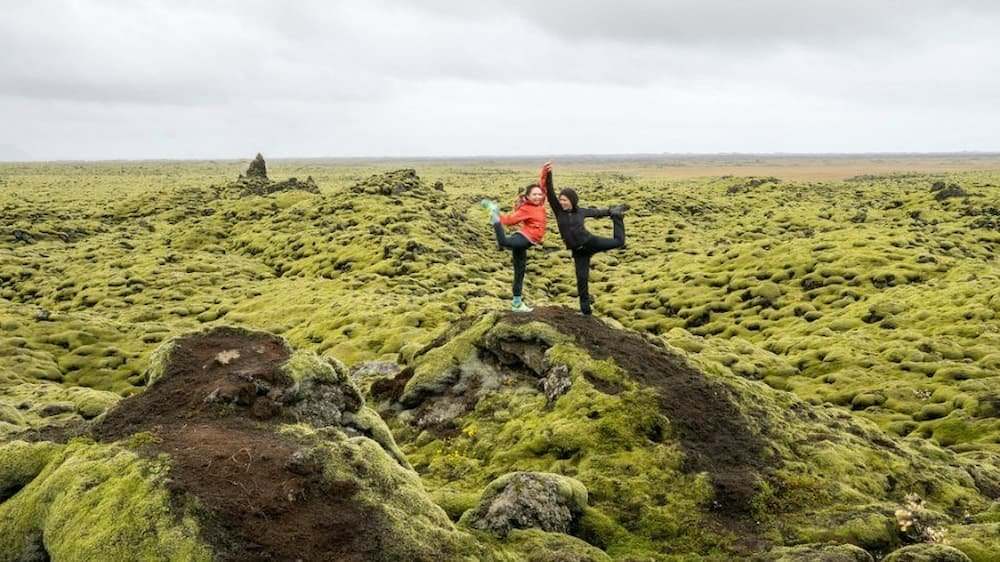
[481,164,548,312]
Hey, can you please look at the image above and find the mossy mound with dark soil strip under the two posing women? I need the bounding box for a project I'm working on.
[371,307,1000,560]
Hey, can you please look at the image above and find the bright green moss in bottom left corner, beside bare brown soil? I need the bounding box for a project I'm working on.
[0,443,212,561]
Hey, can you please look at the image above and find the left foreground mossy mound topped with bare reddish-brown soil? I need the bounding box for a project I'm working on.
[0,327,502,560]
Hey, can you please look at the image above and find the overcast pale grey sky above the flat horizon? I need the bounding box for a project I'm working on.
[0,0,1000,161]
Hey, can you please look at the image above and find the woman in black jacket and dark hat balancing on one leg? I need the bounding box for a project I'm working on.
[539,162,628,316]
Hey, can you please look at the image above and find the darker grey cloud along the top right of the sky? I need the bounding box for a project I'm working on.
[389,0,1000,52]
